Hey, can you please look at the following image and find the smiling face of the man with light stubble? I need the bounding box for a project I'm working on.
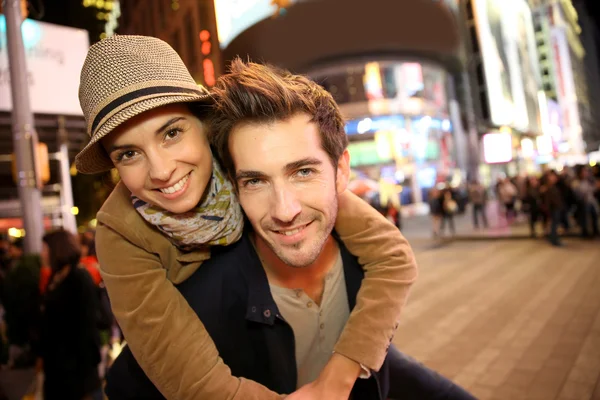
[229,114,350,268]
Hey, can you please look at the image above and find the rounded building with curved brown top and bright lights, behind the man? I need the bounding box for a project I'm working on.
[215,0,464,212]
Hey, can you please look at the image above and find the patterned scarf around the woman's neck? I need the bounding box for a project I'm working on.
[131,159,244,251]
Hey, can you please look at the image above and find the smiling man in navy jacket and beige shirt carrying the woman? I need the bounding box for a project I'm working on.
[106,60,471,399]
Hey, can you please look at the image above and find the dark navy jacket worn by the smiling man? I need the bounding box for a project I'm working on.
[105,233,389,400]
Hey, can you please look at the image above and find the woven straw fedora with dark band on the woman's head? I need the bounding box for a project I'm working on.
[75,35,210,174]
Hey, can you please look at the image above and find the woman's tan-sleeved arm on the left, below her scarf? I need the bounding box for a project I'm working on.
[96,224,282,400]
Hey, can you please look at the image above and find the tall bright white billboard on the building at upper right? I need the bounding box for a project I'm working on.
[474,0,541,132]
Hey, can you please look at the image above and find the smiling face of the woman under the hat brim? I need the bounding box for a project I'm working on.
[102,104,212,214]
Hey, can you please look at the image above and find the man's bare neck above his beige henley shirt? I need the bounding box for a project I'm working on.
[254,235,338,304]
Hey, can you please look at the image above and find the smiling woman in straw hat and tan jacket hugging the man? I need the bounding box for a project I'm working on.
[76,36,416,399]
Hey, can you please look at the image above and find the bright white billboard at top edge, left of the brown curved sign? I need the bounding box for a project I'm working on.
[216,0,298,49]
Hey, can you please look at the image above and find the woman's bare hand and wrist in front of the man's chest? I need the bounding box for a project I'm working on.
[286,353,360,400]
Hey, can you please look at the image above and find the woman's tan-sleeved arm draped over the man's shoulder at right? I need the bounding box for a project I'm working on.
[335,190,417,371]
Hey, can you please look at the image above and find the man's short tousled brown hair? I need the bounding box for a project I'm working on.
[210,58,348,176]
